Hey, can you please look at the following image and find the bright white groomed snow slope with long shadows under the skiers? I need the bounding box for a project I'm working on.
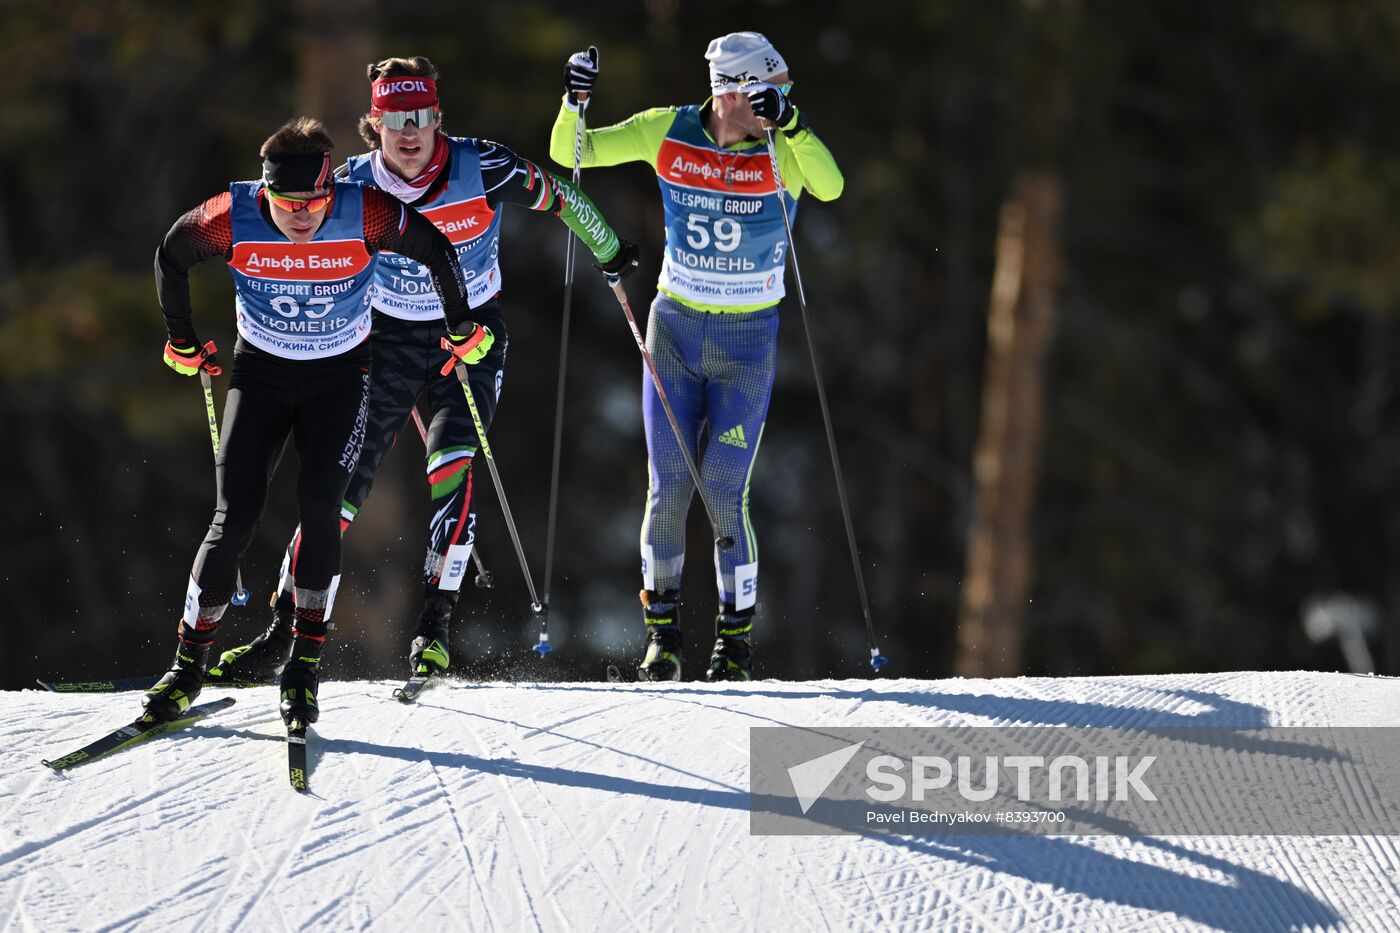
[0,672,1400,930]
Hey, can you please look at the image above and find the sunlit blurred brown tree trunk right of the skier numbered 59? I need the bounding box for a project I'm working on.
[958,171,1061,677]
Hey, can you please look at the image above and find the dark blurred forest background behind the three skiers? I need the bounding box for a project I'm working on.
[0,0,1400,689]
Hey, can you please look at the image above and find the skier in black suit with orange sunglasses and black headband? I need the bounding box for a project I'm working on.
[144,118,493,724]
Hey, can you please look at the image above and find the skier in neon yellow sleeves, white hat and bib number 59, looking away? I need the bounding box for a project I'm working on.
[549,32,844,681]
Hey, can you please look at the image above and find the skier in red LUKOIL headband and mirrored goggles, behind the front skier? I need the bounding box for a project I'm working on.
[209,56,637,681]
